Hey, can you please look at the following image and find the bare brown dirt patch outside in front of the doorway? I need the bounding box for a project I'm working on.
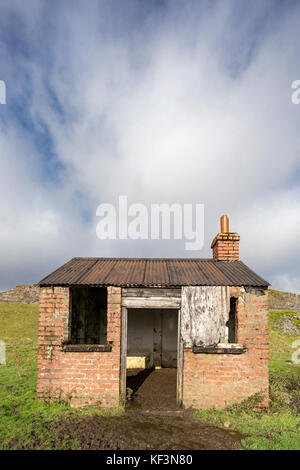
[42,411,240,450]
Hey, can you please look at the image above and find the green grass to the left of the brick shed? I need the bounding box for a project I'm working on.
[0,303,116,450]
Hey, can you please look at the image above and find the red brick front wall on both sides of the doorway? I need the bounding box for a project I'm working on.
[37,287,268,408]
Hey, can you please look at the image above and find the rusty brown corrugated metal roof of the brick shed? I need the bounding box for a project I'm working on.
[39,258,269,287]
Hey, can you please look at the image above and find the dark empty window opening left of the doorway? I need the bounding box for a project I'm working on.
[70,287,107,344]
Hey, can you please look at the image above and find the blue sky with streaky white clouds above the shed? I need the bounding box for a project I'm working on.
[0,0,300,292]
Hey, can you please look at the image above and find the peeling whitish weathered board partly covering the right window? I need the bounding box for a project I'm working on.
[181,286,230,348]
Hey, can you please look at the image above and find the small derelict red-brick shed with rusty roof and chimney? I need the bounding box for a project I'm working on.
[37,219,269,408]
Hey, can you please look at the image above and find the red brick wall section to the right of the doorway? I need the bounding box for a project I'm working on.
[183,288,269,408]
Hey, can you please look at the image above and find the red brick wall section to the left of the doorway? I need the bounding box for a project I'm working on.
[37,287,121,407]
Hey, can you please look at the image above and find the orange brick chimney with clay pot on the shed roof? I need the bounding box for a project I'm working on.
[211,215,240,261]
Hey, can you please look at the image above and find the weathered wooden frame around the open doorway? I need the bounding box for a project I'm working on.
[120,305,183,406]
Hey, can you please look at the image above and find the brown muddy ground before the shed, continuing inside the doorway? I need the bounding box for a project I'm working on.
[10,369,242,450]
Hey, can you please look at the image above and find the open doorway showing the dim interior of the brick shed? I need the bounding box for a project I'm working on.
[126,308,179,410]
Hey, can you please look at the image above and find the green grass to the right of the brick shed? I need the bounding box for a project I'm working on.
[195,310,300,450]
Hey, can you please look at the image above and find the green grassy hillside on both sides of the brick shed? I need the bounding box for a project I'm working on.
[0,303,300,449]
